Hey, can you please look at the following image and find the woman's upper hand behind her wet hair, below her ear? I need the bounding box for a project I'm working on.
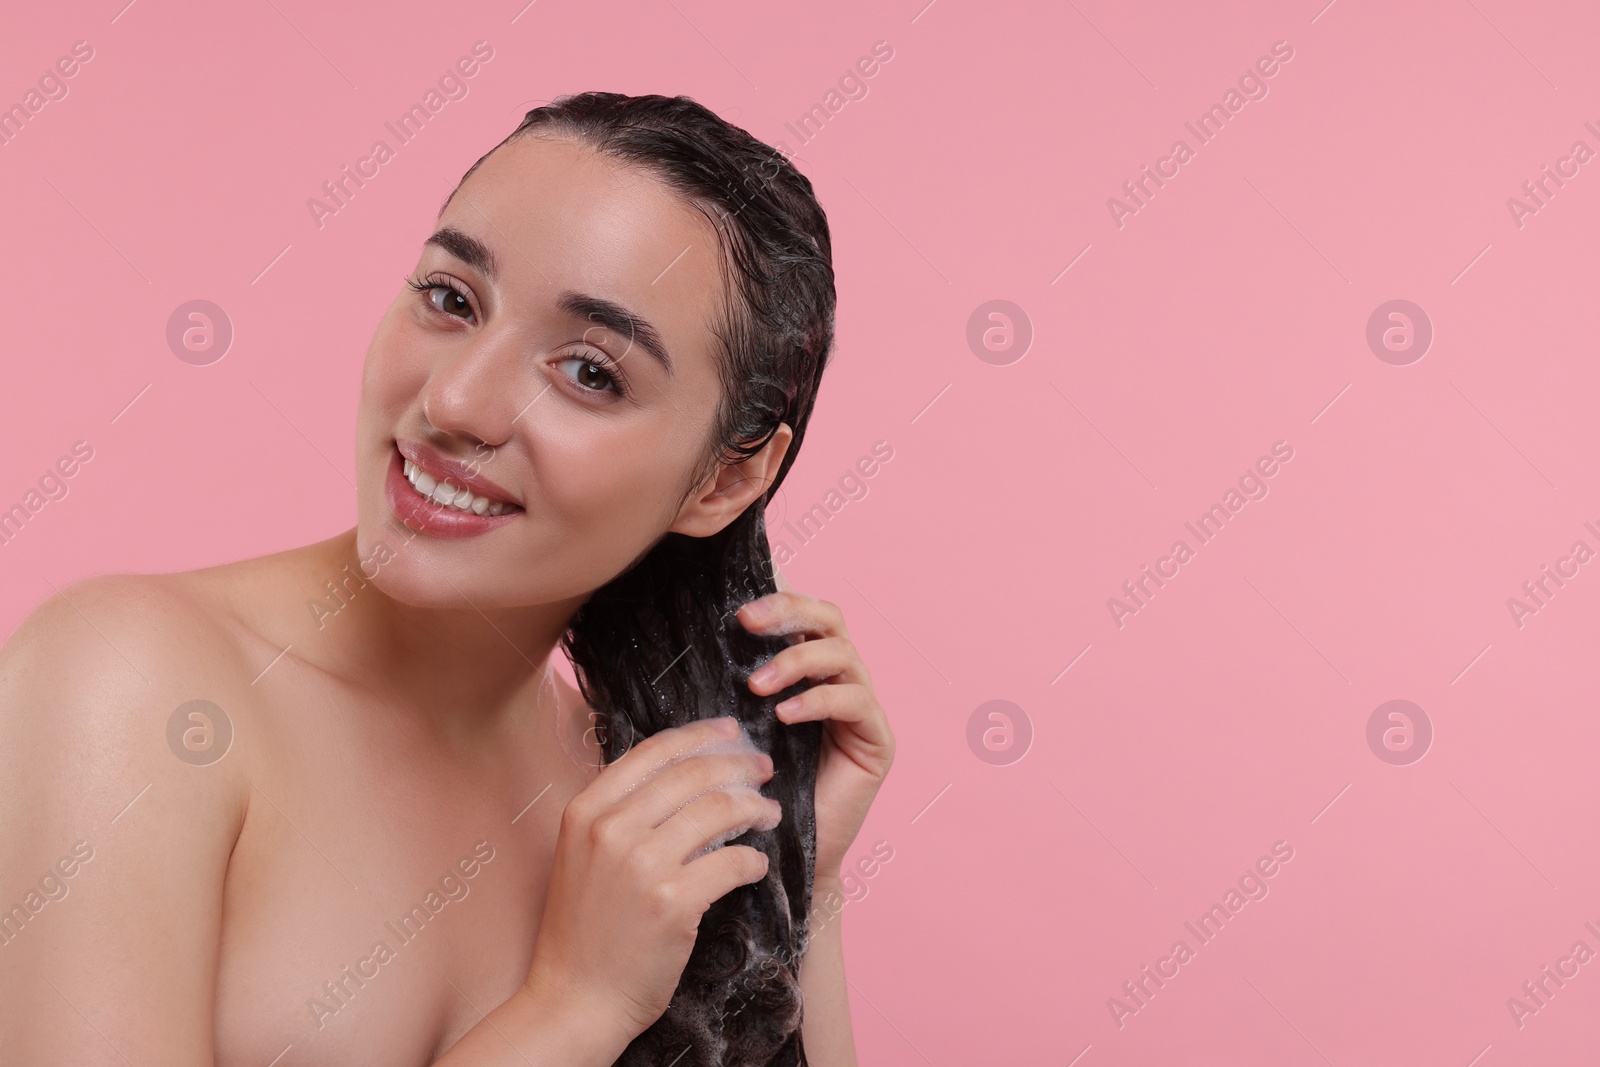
[739,581,894,881]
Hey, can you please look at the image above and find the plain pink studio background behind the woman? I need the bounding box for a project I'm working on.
[0,0,1600,1067]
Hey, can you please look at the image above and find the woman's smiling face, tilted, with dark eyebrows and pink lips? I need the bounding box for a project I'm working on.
[357,136,723,608]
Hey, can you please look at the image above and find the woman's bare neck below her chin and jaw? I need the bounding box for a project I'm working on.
[300,528,581,734]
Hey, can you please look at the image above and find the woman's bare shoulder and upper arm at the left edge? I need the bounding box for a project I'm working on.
[0,579,246,1067]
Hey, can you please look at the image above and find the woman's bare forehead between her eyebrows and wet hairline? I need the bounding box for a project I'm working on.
[438,136,723,355]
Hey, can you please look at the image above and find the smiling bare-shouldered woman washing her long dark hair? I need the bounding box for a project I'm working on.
[0,94,894,1067]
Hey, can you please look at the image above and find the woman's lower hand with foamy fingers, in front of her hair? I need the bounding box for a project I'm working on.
[525,717,779,1041]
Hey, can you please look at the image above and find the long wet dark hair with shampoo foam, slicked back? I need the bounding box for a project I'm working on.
[446,93,835,1067]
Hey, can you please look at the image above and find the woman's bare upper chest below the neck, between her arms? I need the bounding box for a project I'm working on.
[216,687,578,1067]
